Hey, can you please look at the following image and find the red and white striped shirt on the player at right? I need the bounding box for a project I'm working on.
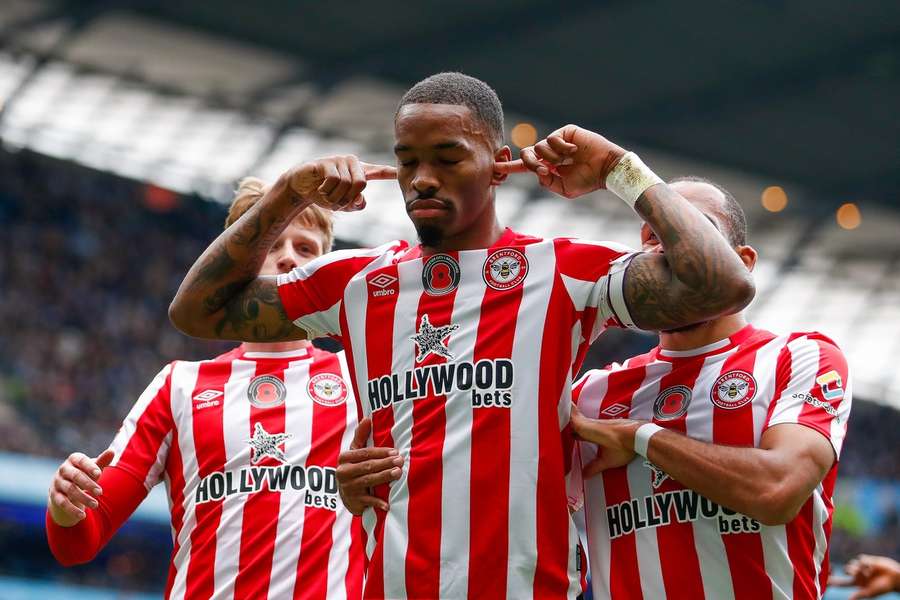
[574,325,851,600]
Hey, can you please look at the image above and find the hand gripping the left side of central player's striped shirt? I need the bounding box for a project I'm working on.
[337,417,403,516]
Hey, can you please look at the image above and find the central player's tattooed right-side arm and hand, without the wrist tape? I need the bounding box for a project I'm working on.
[507,125,754,330]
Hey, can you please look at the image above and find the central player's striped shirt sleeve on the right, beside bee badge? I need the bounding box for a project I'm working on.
[556,239,637,343]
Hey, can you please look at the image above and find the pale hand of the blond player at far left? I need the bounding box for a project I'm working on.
[48,450,115,527]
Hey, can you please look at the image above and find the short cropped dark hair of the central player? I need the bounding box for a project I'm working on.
[394,71,503,147]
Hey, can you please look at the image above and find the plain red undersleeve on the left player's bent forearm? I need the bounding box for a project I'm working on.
[45,467,147,567]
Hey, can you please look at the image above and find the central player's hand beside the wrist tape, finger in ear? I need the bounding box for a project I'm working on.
[495,125,626,198]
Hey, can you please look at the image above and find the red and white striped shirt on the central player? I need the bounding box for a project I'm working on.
[278,229,628,599]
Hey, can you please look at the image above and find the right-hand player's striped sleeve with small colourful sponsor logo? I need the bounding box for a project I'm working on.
[765,336,852,458]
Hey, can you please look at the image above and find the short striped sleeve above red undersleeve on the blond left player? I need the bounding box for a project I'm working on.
[110,363,175,491]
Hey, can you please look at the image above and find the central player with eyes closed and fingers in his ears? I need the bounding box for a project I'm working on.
[170,73,753,598]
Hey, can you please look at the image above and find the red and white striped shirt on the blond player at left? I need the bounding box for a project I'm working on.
[103,346,364,600]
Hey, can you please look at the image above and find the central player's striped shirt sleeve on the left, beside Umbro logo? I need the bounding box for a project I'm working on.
[276,242,403,339]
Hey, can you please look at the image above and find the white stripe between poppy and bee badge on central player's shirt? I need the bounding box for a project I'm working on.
[438,247,487,597]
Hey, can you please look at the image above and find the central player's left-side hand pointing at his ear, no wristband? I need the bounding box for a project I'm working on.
[287,155,397,212]
